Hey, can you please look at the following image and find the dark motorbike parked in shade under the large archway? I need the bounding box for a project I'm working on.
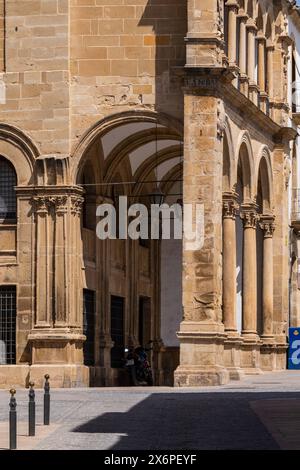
[124,341,153,386]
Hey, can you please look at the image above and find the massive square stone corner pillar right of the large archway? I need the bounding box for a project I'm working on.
[174,71,229,386]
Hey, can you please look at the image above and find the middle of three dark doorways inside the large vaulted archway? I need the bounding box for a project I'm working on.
[110,295,124,368]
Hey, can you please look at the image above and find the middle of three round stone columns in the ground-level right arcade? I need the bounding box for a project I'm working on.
[241,204,257,337]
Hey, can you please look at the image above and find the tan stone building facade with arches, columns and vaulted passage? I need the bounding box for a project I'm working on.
[0,0,296,387]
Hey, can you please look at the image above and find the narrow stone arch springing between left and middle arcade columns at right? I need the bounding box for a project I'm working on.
[235,131,254,202]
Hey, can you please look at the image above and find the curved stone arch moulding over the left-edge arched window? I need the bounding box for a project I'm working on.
[0,123,39,186]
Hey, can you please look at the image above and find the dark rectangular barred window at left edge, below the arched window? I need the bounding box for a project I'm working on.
[0,286,17,365]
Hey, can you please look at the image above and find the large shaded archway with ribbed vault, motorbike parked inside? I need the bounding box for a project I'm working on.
[75,116,182,385]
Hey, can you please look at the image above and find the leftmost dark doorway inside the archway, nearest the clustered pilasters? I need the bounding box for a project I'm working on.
[83,289,96,366]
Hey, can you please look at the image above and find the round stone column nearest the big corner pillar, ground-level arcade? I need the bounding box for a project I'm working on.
[223,193,237,334]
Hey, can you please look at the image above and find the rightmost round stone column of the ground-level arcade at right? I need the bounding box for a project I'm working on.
[260,216,275,339]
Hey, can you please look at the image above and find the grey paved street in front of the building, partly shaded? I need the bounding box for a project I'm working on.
[0,372,300,450]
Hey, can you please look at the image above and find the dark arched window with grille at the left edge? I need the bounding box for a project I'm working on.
[0,156,17,222]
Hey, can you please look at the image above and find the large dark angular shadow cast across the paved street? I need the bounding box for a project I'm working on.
[73,392,300,450]
